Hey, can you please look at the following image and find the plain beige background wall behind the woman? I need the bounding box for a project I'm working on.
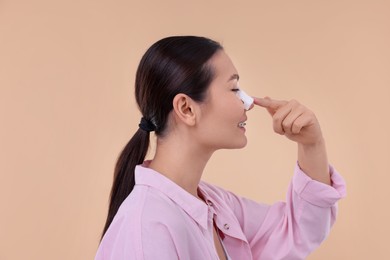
[0,0,390,260]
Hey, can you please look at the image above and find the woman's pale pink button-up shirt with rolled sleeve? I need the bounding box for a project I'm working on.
[95,161,345,260]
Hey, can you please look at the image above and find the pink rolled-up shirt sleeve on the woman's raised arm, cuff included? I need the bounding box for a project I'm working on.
[227,163,346,260]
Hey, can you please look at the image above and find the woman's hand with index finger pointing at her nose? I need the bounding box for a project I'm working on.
[253,97,323,146]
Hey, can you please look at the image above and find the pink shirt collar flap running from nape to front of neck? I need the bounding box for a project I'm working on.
[135,163,212,230]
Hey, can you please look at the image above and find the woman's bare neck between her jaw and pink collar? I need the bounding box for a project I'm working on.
[149,136,213,198]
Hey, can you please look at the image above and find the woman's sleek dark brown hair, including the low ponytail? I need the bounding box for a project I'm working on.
[102,36,222,237]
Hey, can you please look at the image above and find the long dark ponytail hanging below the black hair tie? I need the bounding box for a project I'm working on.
[101,128,149,238]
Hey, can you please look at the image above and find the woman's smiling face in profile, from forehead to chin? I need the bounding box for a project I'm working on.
[197,51,253,150]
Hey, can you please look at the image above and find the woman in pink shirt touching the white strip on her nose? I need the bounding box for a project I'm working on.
[96,36,345,260]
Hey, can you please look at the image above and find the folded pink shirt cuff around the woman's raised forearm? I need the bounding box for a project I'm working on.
[293,162,346,208]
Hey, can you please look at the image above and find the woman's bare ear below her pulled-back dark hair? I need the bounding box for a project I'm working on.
[172,93,196,126]
